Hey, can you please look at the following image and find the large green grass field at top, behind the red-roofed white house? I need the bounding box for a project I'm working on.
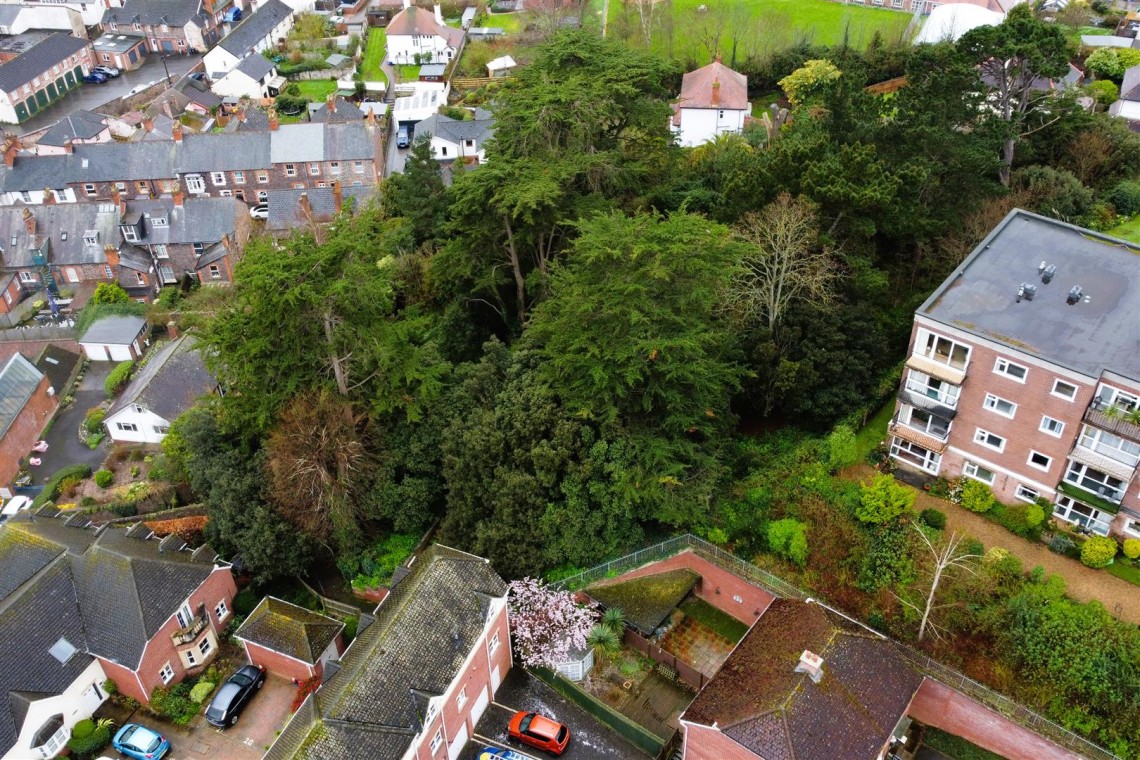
[611,0,911,63]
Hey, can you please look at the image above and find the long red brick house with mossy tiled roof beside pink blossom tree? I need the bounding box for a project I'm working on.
[266,545,511,760]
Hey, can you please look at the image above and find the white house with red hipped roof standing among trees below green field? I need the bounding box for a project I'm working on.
[669,56,751,148]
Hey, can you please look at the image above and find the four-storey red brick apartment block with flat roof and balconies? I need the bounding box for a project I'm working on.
[890,211,1140,538]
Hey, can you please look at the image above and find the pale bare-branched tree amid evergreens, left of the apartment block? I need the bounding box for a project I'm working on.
[728,193,837,330]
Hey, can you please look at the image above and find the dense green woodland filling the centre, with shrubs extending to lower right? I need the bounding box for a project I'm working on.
[164,16,1140,757]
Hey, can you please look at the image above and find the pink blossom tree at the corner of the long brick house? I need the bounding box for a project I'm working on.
[507,578,597,668]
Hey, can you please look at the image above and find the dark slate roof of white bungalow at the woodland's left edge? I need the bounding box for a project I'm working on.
[107,335,218,420]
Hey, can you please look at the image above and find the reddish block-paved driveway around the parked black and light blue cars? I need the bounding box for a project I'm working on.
[105,675,296,760]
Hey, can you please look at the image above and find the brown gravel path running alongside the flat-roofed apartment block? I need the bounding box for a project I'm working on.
[844,465,1140,624]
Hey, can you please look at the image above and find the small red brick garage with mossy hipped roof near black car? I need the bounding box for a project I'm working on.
[234,596,344,683]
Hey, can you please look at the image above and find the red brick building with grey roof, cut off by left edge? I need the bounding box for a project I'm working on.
[0,353,59,498]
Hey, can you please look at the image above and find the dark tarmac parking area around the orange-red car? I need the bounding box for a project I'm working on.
[459,667,649,760]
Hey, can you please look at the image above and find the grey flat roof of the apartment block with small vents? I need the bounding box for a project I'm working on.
[918,210,1140,381]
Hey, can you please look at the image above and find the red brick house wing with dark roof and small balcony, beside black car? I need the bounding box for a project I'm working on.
[9,507,237,702]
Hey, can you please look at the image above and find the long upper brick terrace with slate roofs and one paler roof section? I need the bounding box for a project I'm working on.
[0,113,383,206]
